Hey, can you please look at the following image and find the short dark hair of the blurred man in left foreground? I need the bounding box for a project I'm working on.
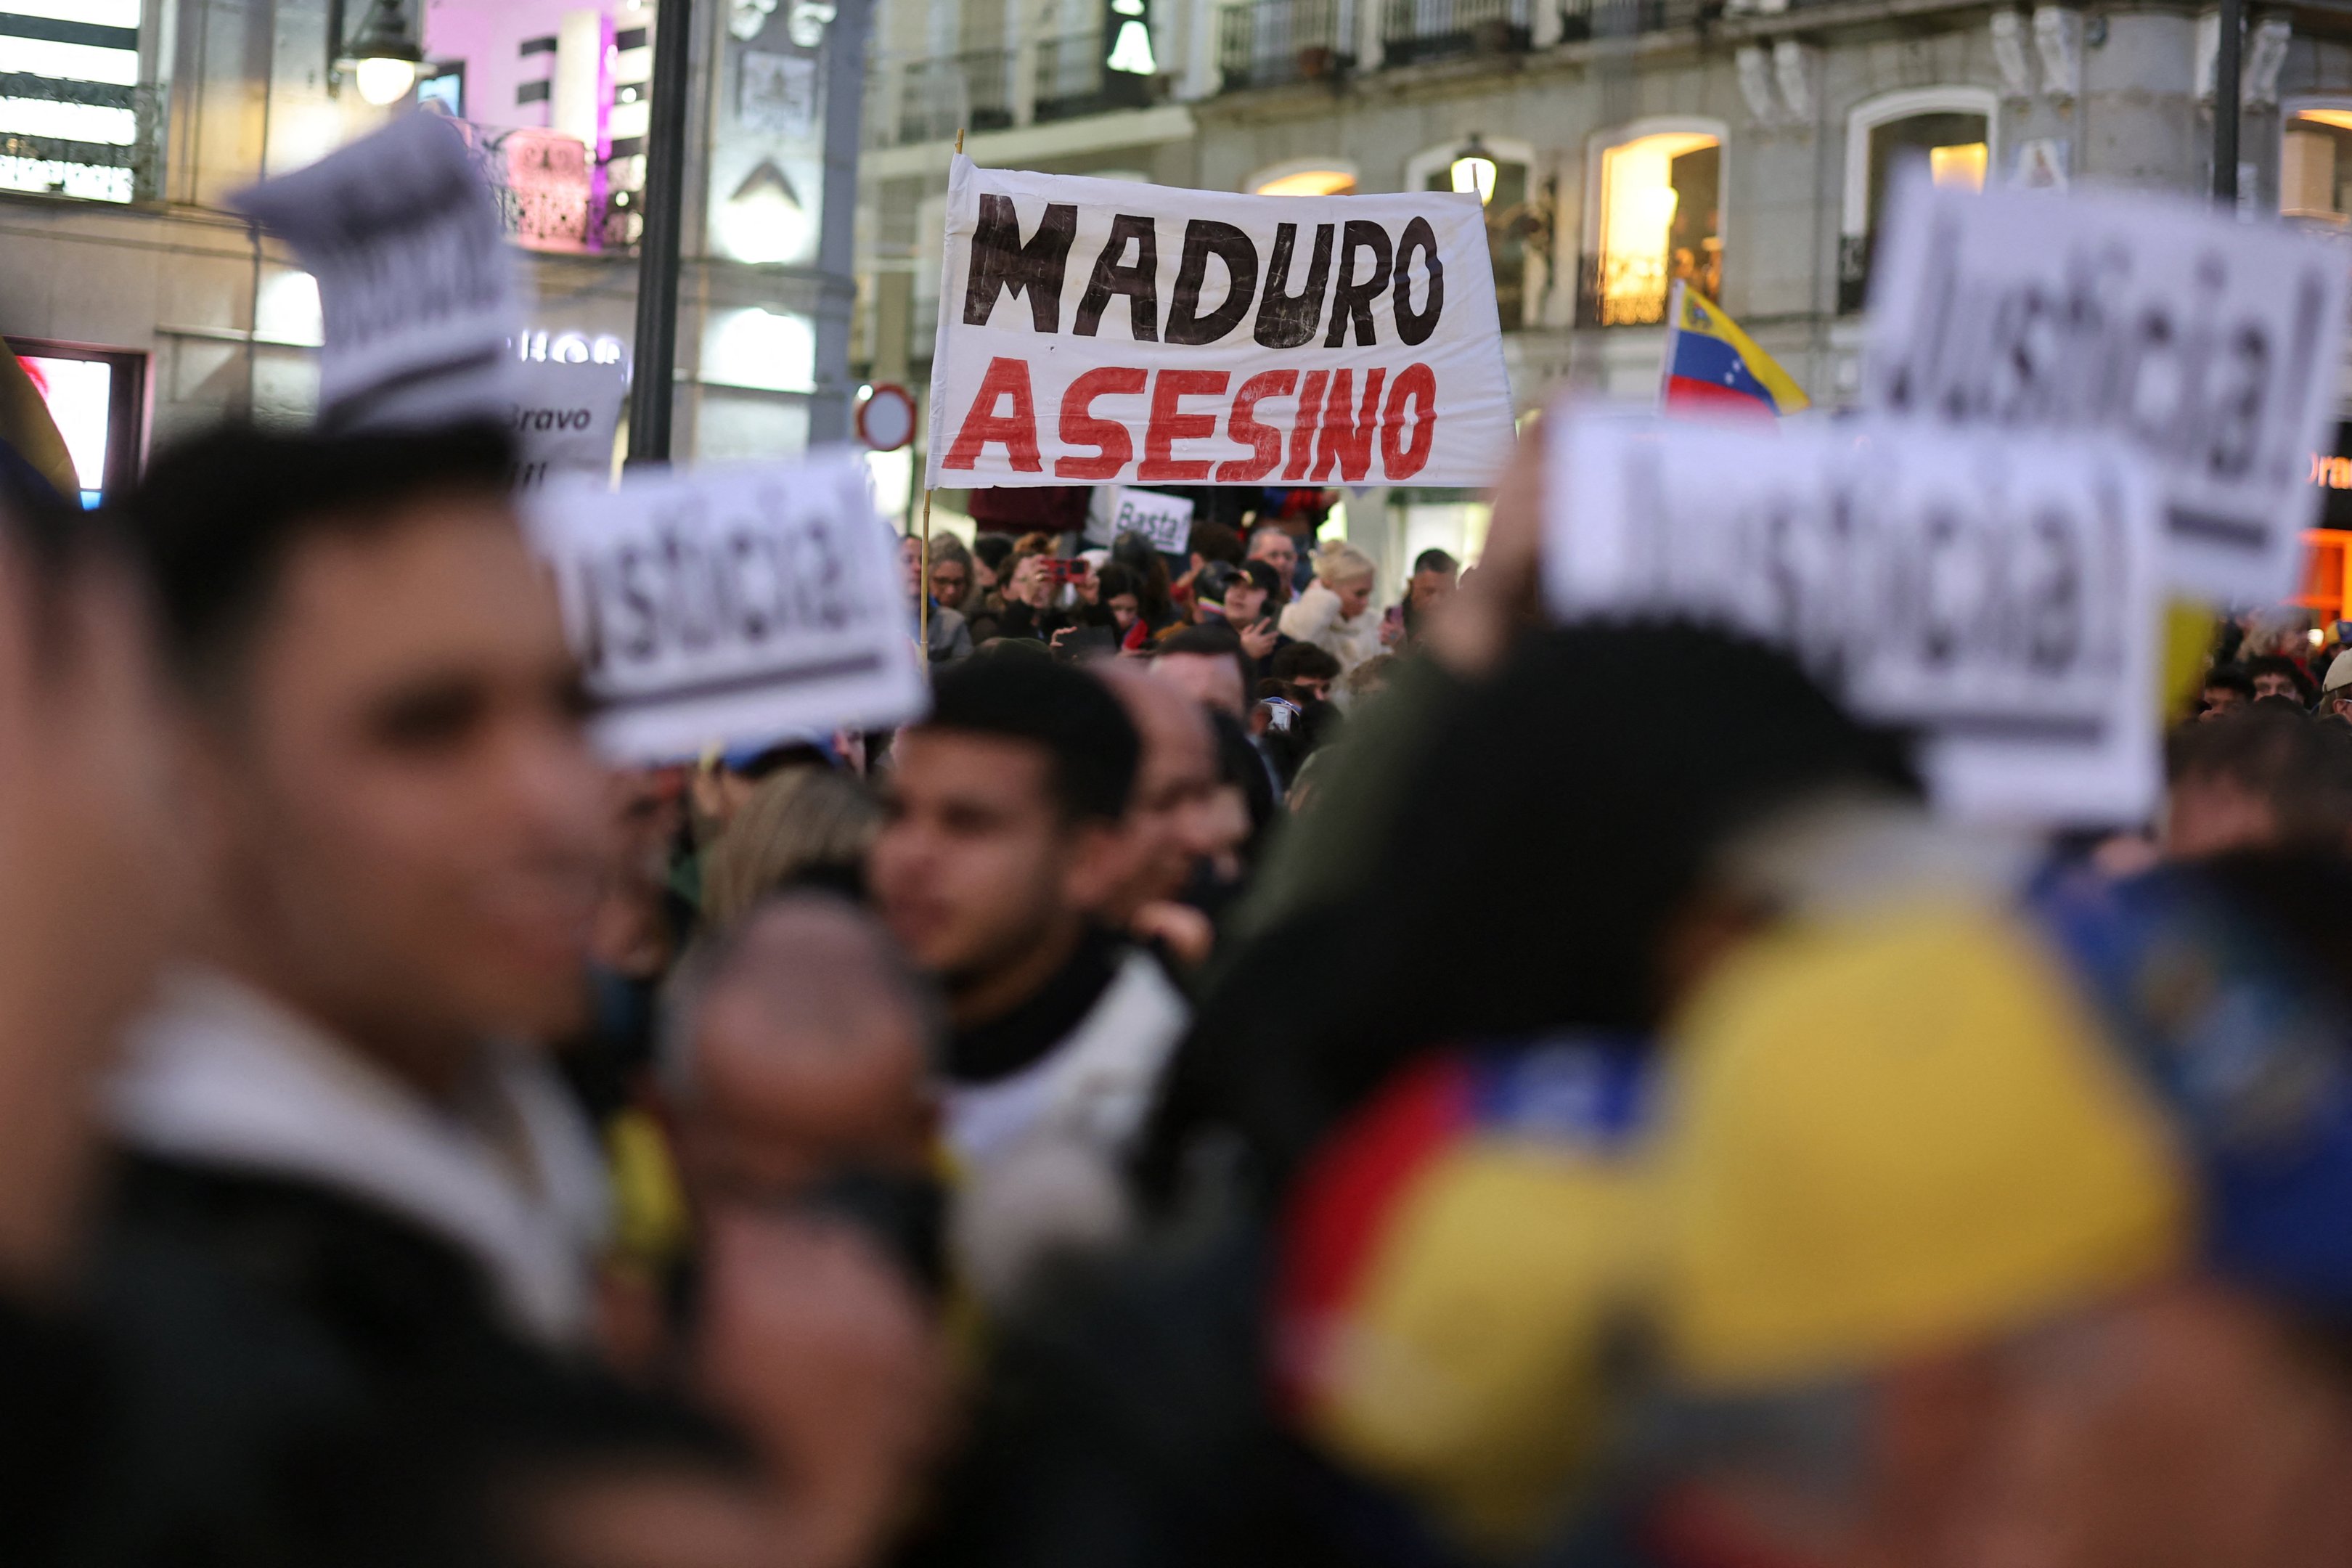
[122,423,515,696]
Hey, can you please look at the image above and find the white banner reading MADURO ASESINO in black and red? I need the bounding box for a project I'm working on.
[924,158,1512,486]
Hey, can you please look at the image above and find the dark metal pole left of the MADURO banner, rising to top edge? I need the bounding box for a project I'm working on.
[628,0,694,463]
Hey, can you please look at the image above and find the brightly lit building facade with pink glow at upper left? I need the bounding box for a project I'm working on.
[0,0,865,494]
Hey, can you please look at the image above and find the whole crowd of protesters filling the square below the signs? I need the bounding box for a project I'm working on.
[0,411,2352,1568]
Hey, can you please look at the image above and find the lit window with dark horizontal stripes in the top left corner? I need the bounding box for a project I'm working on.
[0,0,144,203]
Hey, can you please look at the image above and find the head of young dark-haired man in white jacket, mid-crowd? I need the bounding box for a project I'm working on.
[868,658,1143,1020]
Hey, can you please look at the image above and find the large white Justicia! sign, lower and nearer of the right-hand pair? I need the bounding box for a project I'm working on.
[1543,414,2162,822]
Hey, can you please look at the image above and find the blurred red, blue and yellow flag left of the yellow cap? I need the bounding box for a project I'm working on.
[1273,1037,1658,1561]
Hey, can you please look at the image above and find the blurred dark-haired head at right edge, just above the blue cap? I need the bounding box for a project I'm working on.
[2162,703,2352,858]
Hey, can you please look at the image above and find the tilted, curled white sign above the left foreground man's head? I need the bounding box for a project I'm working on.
[233,110,522,430]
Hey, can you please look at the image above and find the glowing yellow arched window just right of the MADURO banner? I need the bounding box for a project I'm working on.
[1576,125,1724,327]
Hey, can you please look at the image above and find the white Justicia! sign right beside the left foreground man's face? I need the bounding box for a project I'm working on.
[529,454,927,761]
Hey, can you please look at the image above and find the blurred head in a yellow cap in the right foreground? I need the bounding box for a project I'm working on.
[1649,896,2192,1566]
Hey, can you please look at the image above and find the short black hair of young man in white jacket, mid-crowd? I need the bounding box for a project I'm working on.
[918,658,1143,820]
